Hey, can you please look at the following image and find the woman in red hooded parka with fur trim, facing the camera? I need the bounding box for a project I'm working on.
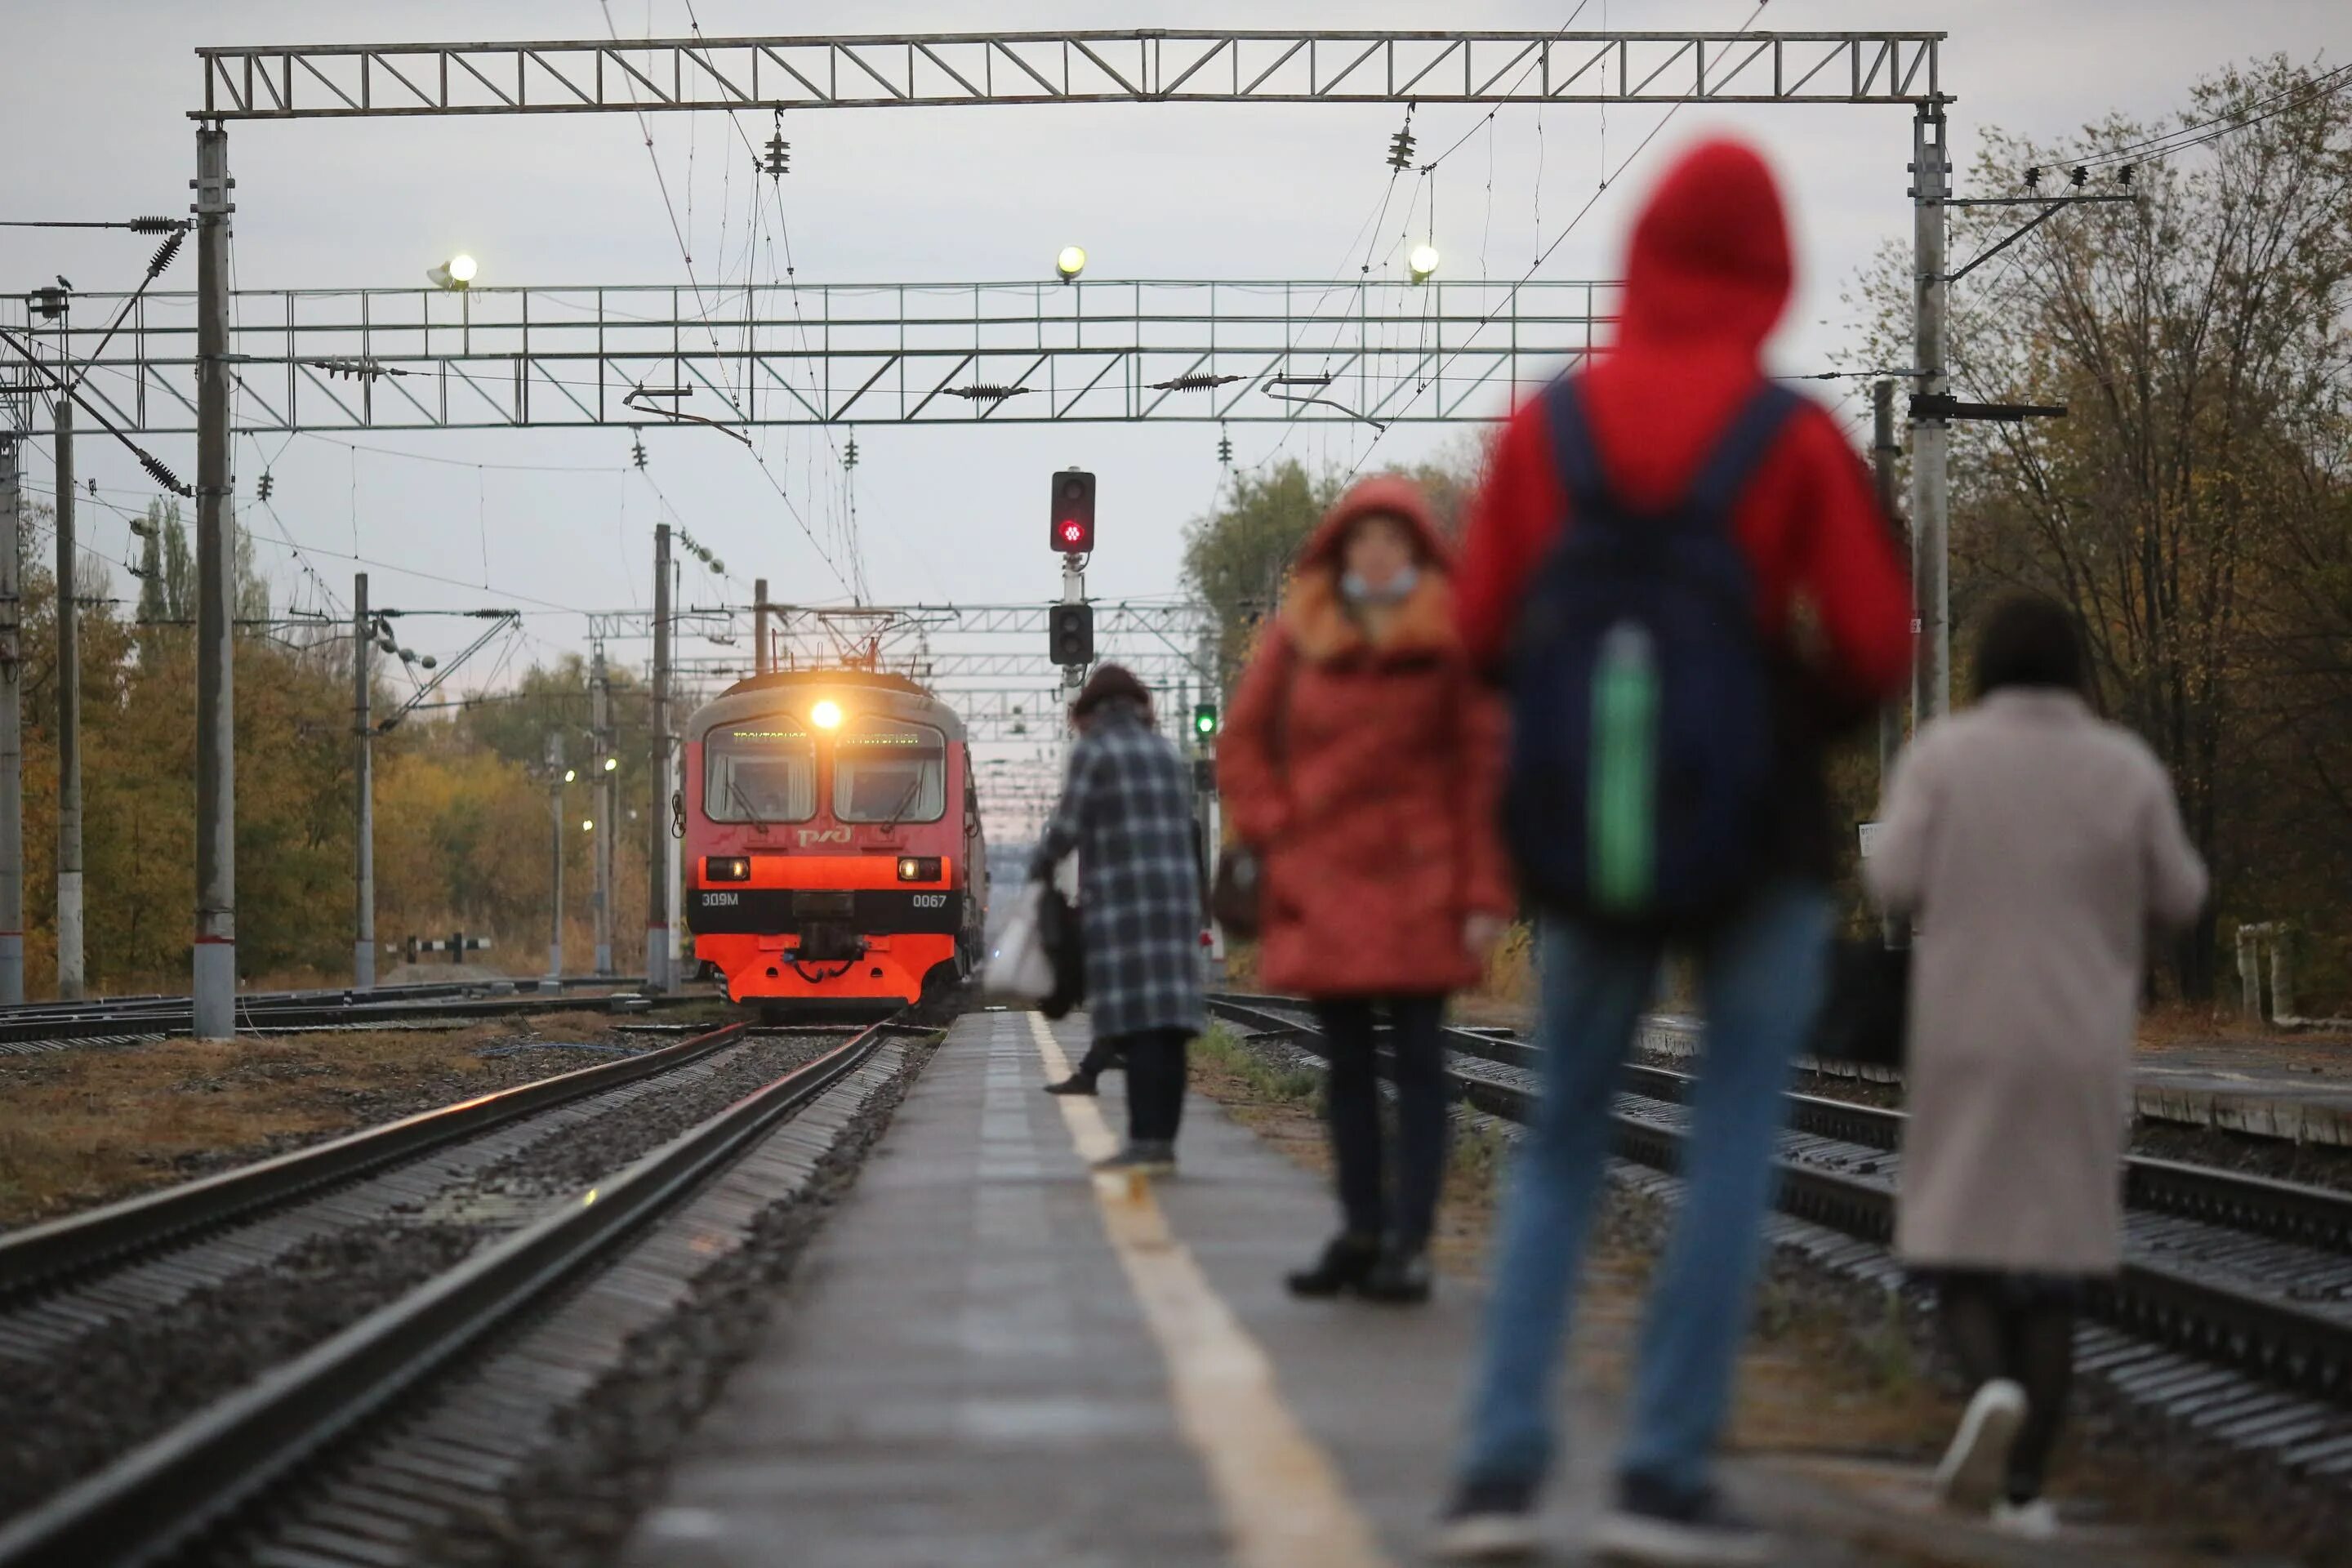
[1216,477,1512,1303]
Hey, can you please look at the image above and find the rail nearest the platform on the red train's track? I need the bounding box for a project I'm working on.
[0,1020,896,1568]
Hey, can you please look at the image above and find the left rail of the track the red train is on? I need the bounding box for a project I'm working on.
[0,1022,748,1303]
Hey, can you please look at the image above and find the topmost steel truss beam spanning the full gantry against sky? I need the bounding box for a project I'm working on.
[188,29,1945,122]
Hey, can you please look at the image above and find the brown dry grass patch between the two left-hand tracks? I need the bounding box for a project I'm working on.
[0,1013,644,1225]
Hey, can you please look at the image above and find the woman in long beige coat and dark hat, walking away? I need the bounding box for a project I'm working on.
[1863,597,2206,1535]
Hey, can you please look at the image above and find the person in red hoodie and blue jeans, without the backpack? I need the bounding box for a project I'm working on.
[1437,141,1912,1563]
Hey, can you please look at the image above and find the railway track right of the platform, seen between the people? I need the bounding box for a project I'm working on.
[1211,995,2352,1477]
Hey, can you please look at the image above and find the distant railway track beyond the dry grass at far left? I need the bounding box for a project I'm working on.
[0,978,682,1055]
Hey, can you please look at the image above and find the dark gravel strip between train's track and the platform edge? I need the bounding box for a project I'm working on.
[207,1041,936,1568]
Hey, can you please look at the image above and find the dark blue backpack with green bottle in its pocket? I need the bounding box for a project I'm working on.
[1503,378,1799,933]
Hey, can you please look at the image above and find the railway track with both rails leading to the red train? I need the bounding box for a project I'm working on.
[0,1020,903,1568]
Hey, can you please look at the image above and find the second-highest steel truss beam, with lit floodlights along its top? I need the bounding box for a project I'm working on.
[0,280,1620,435]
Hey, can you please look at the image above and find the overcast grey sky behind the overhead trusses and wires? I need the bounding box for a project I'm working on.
[0,0,2352,700]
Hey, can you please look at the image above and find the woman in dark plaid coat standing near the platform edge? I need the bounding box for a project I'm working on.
[1030,666,1206,1175]
